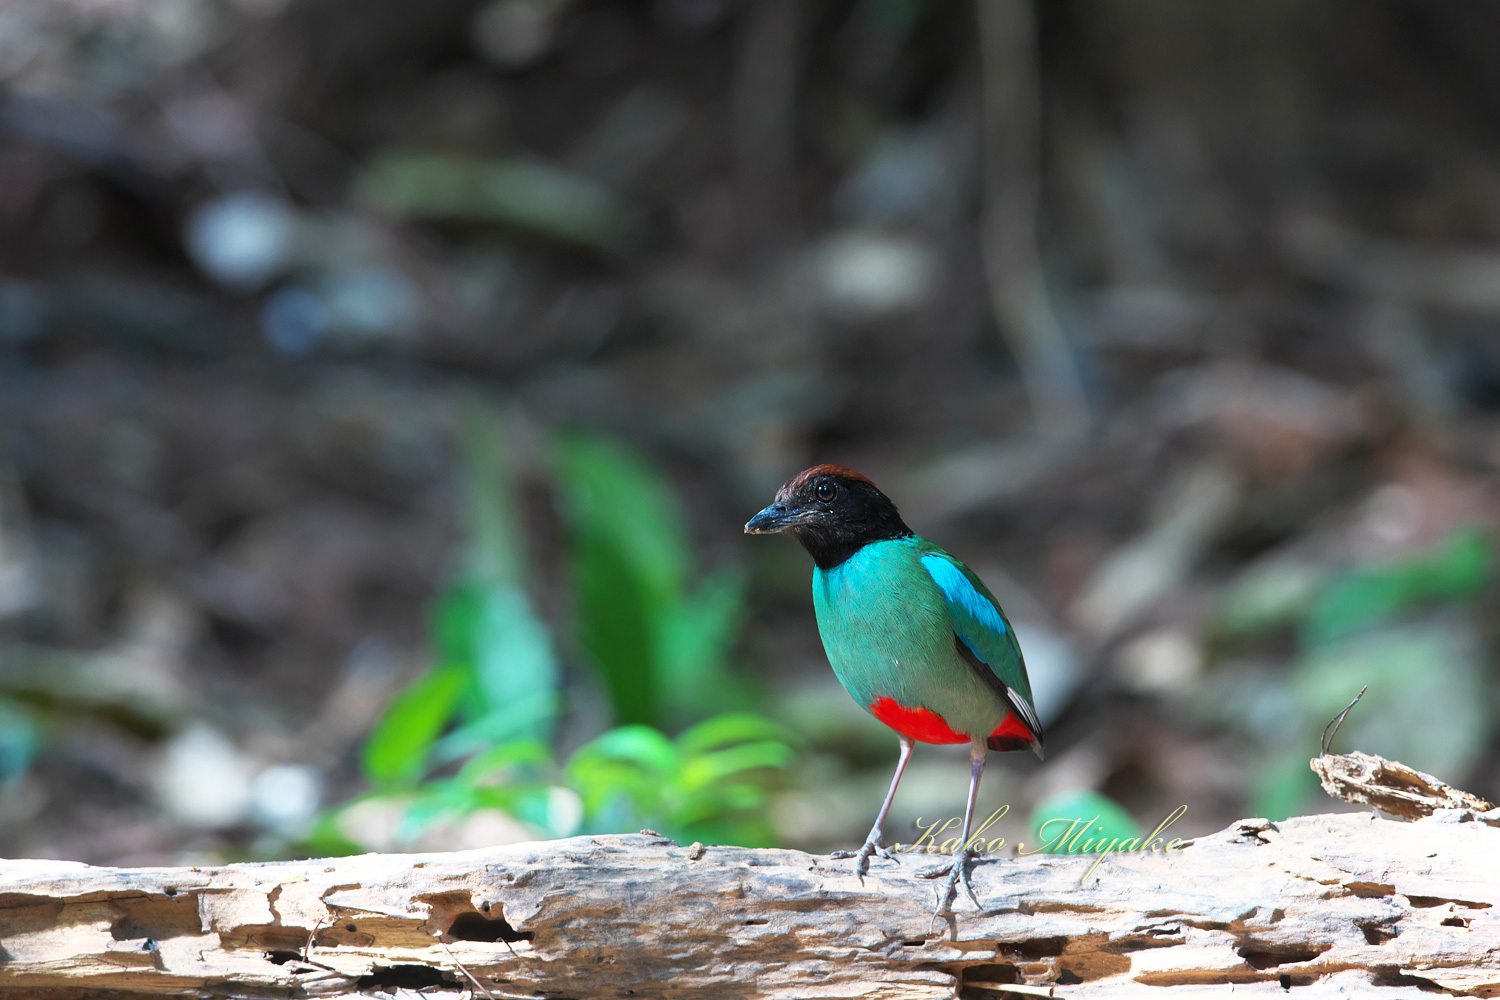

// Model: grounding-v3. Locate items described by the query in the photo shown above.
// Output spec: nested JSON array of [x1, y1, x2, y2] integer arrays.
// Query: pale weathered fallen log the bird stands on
[[0, 813, 1500, 1000]]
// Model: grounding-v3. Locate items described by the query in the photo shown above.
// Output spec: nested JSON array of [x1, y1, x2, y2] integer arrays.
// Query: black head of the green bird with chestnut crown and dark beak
[[746, 465, 912, 570]]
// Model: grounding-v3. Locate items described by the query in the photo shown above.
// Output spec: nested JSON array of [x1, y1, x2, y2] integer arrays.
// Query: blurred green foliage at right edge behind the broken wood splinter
[[1205, 528, 1496, 820]]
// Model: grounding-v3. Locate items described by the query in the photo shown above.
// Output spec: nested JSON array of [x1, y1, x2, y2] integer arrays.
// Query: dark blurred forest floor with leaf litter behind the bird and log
[[0, 0, 1500, 864]]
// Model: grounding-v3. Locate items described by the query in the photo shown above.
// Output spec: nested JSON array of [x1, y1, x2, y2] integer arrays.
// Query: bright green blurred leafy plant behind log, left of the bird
[[311, 412, 792, 853]]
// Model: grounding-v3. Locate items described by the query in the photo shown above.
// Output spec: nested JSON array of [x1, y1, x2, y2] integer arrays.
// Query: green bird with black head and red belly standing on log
[[746, 465, 1044, 921]]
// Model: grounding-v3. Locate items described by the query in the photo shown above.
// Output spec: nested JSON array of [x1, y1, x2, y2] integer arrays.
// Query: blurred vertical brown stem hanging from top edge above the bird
[[975, 0, 1089, 438]]
